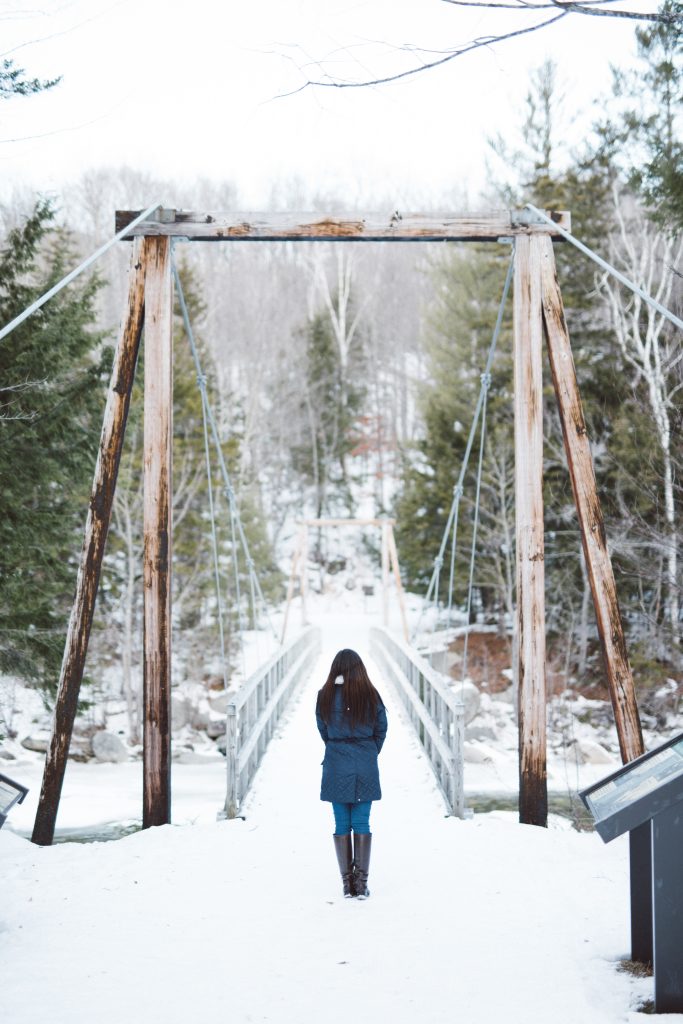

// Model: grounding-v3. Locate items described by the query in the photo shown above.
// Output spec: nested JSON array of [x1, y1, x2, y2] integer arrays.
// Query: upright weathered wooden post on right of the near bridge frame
[[514, 236, 548, 825]]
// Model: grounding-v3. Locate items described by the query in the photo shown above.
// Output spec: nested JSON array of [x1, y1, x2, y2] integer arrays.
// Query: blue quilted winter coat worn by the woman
[[315, 685, 387, 804]]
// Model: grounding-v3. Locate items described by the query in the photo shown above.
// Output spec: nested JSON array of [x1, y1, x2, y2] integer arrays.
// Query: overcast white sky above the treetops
[[0, 0, 656, 209]]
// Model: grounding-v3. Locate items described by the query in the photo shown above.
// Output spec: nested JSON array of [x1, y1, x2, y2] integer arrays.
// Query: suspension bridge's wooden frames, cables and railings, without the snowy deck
[[6, 205, 671, 845]]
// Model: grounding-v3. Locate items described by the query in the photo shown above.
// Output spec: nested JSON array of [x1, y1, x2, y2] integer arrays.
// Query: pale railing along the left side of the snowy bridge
[[224, 627, 321, 818]]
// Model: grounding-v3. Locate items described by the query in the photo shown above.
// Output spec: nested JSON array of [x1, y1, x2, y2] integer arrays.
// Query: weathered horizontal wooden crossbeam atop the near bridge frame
[[116, 210, 571, 242]]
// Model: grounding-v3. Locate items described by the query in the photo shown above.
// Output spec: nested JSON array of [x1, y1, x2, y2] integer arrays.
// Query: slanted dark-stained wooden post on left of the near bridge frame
[[32, 239, 146, 846]]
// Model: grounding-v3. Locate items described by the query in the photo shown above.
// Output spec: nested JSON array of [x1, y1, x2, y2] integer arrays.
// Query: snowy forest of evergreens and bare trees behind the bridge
[[0, 5, 683, 741]]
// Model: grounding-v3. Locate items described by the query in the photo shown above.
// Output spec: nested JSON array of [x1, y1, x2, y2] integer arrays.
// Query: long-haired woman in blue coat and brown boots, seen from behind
[[315, 649, 387, 899]]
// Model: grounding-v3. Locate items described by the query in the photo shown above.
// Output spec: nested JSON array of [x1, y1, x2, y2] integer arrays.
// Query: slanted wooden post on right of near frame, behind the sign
[[538, 238, 644, 763]]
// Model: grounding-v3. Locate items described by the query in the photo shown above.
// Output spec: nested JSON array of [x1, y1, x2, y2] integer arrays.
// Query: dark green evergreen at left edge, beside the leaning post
[[0, 202, 111, 693]]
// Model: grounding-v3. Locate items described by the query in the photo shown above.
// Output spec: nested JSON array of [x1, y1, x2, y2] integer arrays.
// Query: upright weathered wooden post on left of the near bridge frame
[[142, 238, 173, 828]]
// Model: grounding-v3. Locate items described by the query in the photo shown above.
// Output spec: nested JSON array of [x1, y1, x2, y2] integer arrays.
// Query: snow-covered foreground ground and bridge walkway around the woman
[[0, 616, 663, 1024]]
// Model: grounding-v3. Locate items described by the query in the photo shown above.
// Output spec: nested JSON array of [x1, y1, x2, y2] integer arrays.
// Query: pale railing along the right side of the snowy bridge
[[370, 629, 465, 818]]
